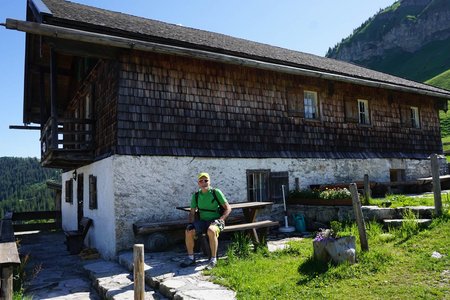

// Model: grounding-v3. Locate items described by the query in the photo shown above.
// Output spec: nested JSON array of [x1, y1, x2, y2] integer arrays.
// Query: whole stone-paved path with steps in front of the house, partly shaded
[[16, 232, 298, 300]]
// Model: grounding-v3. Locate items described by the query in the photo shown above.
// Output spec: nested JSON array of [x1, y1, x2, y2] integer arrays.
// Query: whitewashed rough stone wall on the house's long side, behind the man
[[109, 155, 430, 255]]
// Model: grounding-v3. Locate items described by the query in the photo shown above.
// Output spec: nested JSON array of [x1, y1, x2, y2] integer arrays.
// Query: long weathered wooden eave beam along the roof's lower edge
[[5, 19, 450, 100]]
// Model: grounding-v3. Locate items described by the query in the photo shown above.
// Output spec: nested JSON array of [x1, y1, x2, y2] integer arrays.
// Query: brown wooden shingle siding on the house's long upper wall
[[111, 52, 441, 158]]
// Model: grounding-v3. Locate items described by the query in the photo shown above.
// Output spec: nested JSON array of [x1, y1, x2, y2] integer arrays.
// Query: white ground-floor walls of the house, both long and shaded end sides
[[62, 155, 431, 258]]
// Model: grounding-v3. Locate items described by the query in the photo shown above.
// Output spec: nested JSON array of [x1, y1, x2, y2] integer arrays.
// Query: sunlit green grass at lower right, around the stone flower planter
[[211, 211, 450, 299]]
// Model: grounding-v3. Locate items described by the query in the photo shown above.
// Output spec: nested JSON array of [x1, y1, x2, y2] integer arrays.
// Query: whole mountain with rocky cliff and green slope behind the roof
[[326, 0, 450, 82]]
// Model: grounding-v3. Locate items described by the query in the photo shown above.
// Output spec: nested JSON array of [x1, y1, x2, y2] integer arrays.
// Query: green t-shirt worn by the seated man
[[191, 188, 228, 221]]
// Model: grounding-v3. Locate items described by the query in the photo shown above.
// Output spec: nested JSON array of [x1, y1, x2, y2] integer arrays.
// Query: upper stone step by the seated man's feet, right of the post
[[118, 251, 236, 300]]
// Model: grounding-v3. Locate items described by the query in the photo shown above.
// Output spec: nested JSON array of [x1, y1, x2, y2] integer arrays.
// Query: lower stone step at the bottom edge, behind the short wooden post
[[83, 259, 166, 300]]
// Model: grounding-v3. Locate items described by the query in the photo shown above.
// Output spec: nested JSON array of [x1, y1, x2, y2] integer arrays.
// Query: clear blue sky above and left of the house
[[0, 0, 395, 157]]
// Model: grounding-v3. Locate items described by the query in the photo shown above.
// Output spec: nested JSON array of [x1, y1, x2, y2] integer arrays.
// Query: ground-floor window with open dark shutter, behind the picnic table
[[247, 170, 289, 203]]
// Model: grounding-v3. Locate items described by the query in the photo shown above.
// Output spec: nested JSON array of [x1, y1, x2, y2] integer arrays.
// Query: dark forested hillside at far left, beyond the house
[[0, 157, 61, 217]]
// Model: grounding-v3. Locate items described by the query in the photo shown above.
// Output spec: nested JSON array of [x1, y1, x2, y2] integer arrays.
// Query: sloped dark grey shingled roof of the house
[[34, 0, 450, 98]]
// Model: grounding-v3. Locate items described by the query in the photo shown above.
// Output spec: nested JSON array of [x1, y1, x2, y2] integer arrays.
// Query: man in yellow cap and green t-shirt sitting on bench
[[180, 173, 231, 269]]
